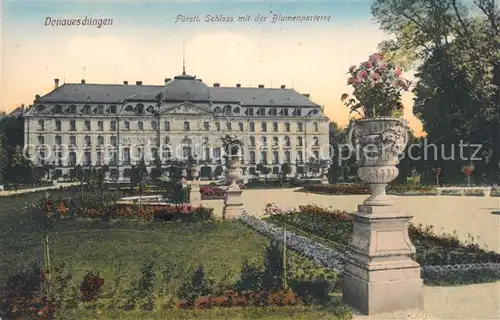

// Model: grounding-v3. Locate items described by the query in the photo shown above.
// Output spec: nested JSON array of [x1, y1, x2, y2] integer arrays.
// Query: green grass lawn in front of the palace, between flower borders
[[0, 190, 349, 320]]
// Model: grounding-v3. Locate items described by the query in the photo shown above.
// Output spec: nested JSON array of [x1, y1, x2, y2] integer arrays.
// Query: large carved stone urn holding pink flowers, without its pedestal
[[352, 117, 409, 206]]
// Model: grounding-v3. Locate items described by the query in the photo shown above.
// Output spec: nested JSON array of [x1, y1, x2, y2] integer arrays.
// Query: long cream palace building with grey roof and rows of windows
[[24, 71, 329, 177]]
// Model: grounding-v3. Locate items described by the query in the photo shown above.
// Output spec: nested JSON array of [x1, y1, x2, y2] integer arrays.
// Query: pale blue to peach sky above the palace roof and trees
[[0, 0, 422, 135]]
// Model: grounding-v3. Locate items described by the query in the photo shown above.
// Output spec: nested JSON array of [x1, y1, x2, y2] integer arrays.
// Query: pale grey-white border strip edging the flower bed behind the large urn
[[240, 214, 500, 279]]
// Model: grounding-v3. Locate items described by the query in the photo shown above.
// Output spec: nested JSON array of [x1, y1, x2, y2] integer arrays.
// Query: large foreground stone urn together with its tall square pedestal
[[343, 118, 423, 314]]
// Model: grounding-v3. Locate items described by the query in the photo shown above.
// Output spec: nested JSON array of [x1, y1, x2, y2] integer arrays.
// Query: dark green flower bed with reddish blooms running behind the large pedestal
[[266, 205, 500, 266]]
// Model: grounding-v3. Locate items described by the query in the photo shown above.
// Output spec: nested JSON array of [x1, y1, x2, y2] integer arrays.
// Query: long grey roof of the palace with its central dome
[[40, 79, 319, 107]]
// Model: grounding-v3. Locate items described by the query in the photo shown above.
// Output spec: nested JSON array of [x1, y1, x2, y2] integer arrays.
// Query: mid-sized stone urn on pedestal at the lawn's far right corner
[[222, 157, 245, 219]]
